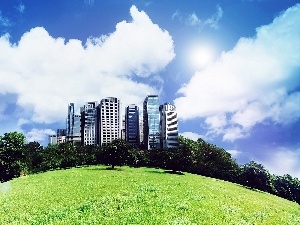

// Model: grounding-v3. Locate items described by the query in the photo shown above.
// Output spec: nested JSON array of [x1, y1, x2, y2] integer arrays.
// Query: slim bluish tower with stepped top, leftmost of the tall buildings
[[66, 103, 81, 144]]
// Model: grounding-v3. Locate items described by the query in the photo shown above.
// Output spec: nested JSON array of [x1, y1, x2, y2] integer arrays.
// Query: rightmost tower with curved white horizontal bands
[[159, 103, 179, 148]]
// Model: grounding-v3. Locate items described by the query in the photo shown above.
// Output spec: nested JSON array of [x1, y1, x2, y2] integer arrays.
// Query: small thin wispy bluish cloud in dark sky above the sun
[[172, 5, 223, 29]]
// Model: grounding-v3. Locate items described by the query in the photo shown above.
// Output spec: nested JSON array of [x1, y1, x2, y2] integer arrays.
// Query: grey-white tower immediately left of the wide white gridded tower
[[80, 102, 98, 145]]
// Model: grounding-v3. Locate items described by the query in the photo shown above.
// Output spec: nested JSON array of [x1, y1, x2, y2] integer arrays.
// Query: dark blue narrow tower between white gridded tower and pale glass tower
[[125, 104, 140, 146]]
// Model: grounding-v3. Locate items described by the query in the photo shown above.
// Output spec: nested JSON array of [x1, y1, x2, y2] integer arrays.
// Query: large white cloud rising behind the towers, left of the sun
[[0, 4, 175, 123]]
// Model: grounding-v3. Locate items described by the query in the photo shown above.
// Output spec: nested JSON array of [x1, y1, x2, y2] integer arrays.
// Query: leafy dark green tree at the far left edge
[[0, 132, 27, 181]]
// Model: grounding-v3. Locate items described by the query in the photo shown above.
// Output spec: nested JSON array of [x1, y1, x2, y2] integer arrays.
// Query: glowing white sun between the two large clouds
[[189, 45, 214, 69]]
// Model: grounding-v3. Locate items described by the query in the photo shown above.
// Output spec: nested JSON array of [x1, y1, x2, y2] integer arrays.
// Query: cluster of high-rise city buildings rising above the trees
[[49, 95, 178, 149]]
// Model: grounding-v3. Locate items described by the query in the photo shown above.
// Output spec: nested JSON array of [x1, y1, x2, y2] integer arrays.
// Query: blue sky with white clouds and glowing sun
[[0, 0, 300, 178]]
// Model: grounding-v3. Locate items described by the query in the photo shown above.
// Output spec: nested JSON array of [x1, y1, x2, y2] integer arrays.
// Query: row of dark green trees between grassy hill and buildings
[[0, 132, 300, 204]]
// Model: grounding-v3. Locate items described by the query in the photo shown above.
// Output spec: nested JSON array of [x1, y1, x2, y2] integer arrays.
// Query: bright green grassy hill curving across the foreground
[[0, 166, 300, 225]]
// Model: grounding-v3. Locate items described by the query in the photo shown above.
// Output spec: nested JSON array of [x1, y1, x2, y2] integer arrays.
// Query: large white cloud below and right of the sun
[[175, 4, 300, 141]]
